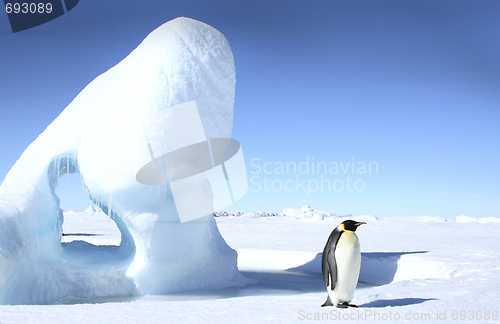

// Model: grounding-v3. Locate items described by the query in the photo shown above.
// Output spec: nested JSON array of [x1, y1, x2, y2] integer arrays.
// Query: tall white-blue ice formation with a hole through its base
[[0, 18, 238, 304]]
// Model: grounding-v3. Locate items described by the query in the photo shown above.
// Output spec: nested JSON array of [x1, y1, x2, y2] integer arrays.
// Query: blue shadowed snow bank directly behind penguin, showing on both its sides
[[288, 251, 429, 286]]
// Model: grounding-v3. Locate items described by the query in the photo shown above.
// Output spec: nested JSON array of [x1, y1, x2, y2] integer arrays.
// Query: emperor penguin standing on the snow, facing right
[[321, 220, 366, 308]]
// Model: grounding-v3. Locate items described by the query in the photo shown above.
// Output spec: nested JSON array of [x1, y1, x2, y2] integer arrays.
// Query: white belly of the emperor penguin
[[327, 231, 361, 305]]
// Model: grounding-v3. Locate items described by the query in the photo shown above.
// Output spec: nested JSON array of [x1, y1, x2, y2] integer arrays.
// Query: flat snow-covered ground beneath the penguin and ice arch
[[0, 211, 500, 324]]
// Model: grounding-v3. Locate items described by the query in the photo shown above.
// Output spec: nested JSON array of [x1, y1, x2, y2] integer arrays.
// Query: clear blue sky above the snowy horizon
[[0, 0, 500, 218]]
